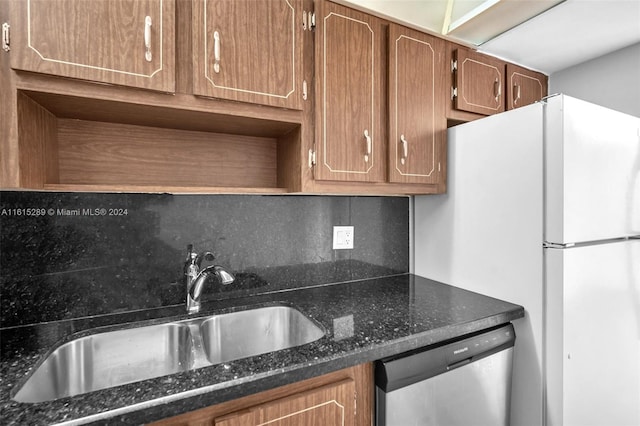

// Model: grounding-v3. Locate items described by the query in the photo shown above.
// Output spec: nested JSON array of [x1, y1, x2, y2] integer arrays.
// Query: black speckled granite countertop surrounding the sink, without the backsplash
[[0, 274, 524, 425]]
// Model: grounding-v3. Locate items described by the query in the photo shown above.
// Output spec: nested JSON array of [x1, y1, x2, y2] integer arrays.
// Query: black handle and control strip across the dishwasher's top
[[375, 323, 516, 392]]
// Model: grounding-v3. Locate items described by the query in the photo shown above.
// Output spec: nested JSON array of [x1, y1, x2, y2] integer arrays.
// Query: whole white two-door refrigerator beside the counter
[[413, 95, 640, 426]]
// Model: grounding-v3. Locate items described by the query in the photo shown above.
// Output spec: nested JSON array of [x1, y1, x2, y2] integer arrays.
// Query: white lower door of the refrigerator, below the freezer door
[[545, 240, 640, 426]]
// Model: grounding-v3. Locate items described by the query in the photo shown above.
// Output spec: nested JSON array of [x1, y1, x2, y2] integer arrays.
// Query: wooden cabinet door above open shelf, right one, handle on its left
[[193, 0, 303, 109]]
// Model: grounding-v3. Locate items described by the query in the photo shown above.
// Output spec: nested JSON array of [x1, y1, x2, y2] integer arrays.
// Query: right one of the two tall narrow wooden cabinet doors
[[389, 24, 447, 184]]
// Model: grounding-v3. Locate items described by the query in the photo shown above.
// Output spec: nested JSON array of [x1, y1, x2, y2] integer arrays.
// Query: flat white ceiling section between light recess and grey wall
[[479, 0, 640, 74]]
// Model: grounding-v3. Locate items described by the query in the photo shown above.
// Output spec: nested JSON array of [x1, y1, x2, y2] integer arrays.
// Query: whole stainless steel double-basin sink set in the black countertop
[[13, 306, 324, 402]]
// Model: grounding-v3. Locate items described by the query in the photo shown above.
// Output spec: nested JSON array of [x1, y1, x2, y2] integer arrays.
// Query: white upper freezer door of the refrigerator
[[545, 95, 640, 243]]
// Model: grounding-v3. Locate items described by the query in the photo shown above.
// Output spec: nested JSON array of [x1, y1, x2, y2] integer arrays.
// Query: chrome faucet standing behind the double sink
[[184, 244, 235, 314]]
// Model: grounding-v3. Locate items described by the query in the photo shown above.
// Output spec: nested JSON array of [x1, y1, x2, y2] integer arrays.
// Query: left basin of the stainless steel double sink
[[13, 323, 192, 402]]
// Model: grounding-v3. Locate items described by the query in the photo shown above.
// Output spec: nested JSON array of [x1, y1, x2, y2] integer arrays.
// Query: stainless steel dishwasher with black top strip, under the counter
[[375, 324, 515, 426]]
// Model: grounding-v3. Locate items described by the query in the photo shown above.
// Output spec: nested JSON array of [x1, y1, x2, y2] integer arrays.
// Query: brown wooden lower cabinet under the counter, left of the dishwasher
[[152, 363, 373, 426]]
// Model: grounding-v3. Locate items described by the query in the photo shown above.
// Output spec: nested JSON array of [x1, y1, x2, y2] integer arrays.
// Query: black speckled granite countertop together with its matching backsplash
[[0, 191, 524, 425]]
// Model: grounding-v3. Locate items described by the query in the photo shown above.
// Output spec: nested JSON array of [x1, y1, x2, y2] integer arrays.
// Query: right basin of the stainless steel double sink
[[201, 306, 324, 364]]
